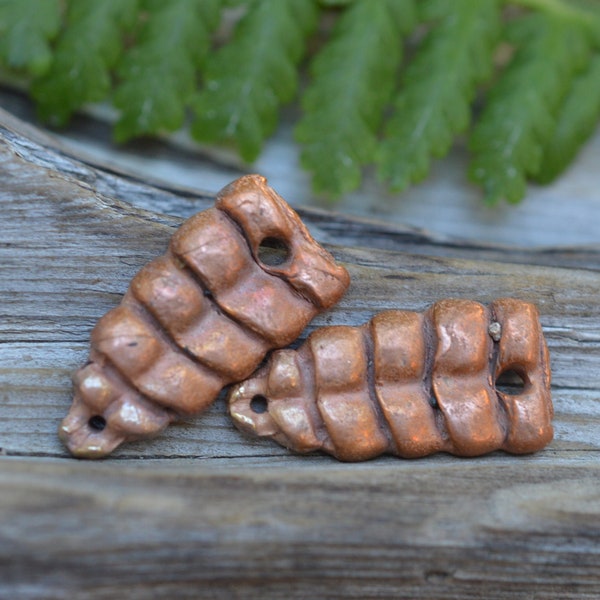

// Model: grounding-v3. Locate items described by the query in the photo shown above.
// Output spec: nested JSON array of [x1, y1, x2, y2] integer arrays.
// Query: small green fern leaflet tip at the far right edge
[[535, 55, 600, 183]]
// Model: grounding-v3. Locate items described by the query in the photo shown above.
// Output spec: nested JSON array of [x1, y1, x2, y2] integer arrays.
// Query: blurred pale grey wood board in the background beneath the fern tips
[[0, 86, 600, 251]]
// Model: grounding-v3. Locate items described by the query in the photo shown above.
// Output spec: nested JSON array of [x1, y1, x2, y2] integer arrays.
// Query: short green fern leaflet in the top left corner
[[0, 0, 61, 75]]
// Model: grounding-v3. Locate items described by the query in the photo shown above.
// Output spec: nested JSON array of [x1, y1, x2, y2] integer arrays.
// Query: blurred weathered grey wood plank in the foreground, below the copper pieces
[[0, 455, 600, 600]]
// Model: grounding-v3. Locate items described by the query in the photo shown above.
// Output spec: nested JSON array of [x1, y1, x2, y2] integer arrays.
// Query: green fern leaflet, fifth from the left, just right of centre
[[295, 0, 415, 195]]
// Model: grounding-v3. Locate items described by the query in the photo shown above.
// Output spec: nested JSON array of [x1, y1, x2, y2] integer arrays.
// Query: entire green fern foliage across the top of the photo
[[0, 0, 600, 203]]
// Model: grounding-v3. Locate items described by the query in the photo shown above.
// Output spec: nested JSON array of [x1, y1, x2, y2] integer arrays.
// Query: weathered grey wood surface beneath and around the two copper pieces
[[0, 113, 600, 600]]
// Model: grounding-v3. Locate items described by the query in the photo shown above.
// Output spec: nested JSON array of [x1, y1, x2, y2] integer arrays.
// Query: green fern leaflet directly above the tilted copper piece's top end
[[192, 0, 318, 162]]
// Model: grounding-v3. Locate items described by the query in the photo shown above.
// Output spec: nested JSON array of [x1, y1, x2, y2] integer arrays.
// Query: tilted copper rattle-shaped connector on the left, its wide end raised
[[59, 175, 349, 458]]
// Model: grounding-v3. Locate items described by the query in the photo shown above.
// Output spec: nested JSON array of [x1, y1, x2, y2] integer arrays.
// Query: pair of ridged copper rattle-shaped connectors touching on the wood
[[59, 175, 552, 461]]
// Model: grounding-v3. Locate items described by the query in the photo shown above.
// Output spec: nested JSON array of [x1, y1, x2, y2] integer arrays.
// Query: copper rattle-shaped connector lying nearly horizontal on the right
[[229, 298, 553, 461]]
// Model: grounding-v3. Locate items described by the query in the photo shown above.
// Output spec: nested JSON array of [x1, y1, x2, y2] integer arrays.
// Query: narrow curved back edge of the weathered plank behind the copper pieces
[[0, 109, 600, 270]]
